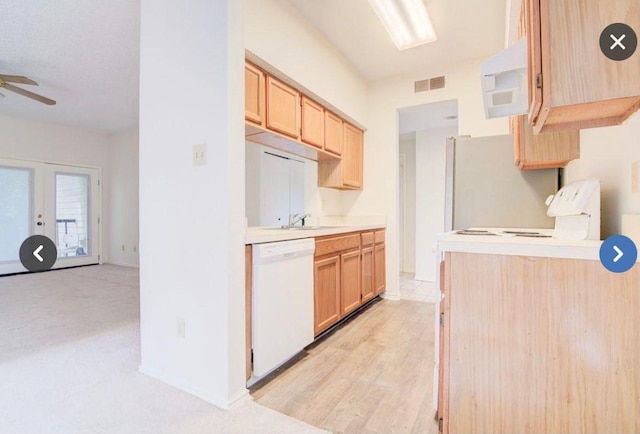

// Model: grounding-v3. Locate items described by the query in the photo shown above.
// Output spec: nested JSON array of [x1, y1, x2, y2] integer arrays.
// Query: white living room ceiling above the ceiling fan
[[0, 0, 140, 131]]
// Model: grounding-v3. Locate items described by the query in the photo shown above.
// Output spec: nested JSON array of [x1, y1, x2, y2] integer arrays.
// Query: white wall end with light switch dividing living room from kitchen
[[139, 0, 247, 407]]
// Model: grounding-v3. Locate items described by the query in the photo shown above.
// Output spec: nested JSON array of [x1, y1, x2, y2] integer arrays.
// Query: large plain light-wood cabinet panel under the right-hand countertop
[[438, 252, 640, 433]]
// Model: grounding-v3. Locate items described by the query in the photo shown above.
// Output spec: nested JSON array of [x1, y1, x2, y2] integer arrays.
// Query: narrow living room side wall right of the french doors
[[105, 127, 140, 267]]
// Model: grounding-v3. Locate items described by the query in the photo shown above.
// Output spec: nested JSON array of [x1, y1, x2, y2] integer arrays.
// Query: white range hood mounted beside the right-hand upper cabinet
[[480, 38, 529, 119]]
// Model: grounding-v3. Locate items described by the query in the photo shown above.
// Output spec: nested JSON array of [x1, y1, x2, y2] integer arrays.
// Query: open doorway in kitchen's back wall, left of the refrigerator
[[398, 100, 458, 288]]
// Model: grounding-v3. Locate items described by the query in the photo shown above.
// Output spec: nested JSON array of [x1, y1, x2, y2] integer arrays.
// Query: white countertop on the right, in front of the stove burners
[[437, 228, 602, 261]]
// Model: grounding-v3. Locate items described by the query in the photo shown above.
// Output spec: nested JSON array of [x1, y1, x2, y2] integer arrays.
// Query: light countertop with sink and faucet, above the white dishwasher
[[244, 224, 386, 244]]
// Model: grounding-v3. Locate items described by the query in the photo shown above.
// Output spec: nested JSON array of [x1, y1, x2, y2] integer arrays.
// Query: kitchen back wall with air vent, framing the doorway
[[342, 59, 508, 297]]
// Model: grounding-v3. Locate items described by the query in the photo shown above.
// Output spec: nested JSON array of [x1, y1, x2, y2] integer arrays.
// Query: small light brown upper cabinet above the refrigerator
[[511, 115, 580, 170]]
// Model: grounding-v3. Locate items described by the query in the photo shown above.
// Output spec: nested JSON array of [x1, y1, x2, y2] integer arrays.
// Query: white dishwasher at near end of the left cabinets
[[248, 238, 315, 385]]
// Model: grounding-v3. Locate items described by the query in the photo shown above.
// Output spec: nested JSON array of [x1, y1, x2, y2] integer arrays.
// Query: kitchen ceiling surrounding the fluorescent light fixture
[[289, 0, 508, 81]]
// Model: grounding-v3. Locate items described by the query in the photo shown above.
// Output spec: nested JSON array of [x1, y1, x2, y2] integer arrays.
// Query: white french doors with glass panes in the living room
[[0, 159, 101, 275]]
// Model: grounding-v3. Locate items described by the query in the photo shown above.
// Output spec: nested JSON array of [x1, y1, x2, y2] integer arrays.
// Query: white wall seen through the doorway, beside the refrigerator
[[416, 128, 458, 282]]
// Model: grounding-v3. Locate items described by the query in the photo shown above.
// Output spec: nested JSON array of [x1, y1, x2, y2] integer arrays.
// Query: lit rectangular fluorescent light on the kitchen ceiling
[[369, 0, 437, 50]]
